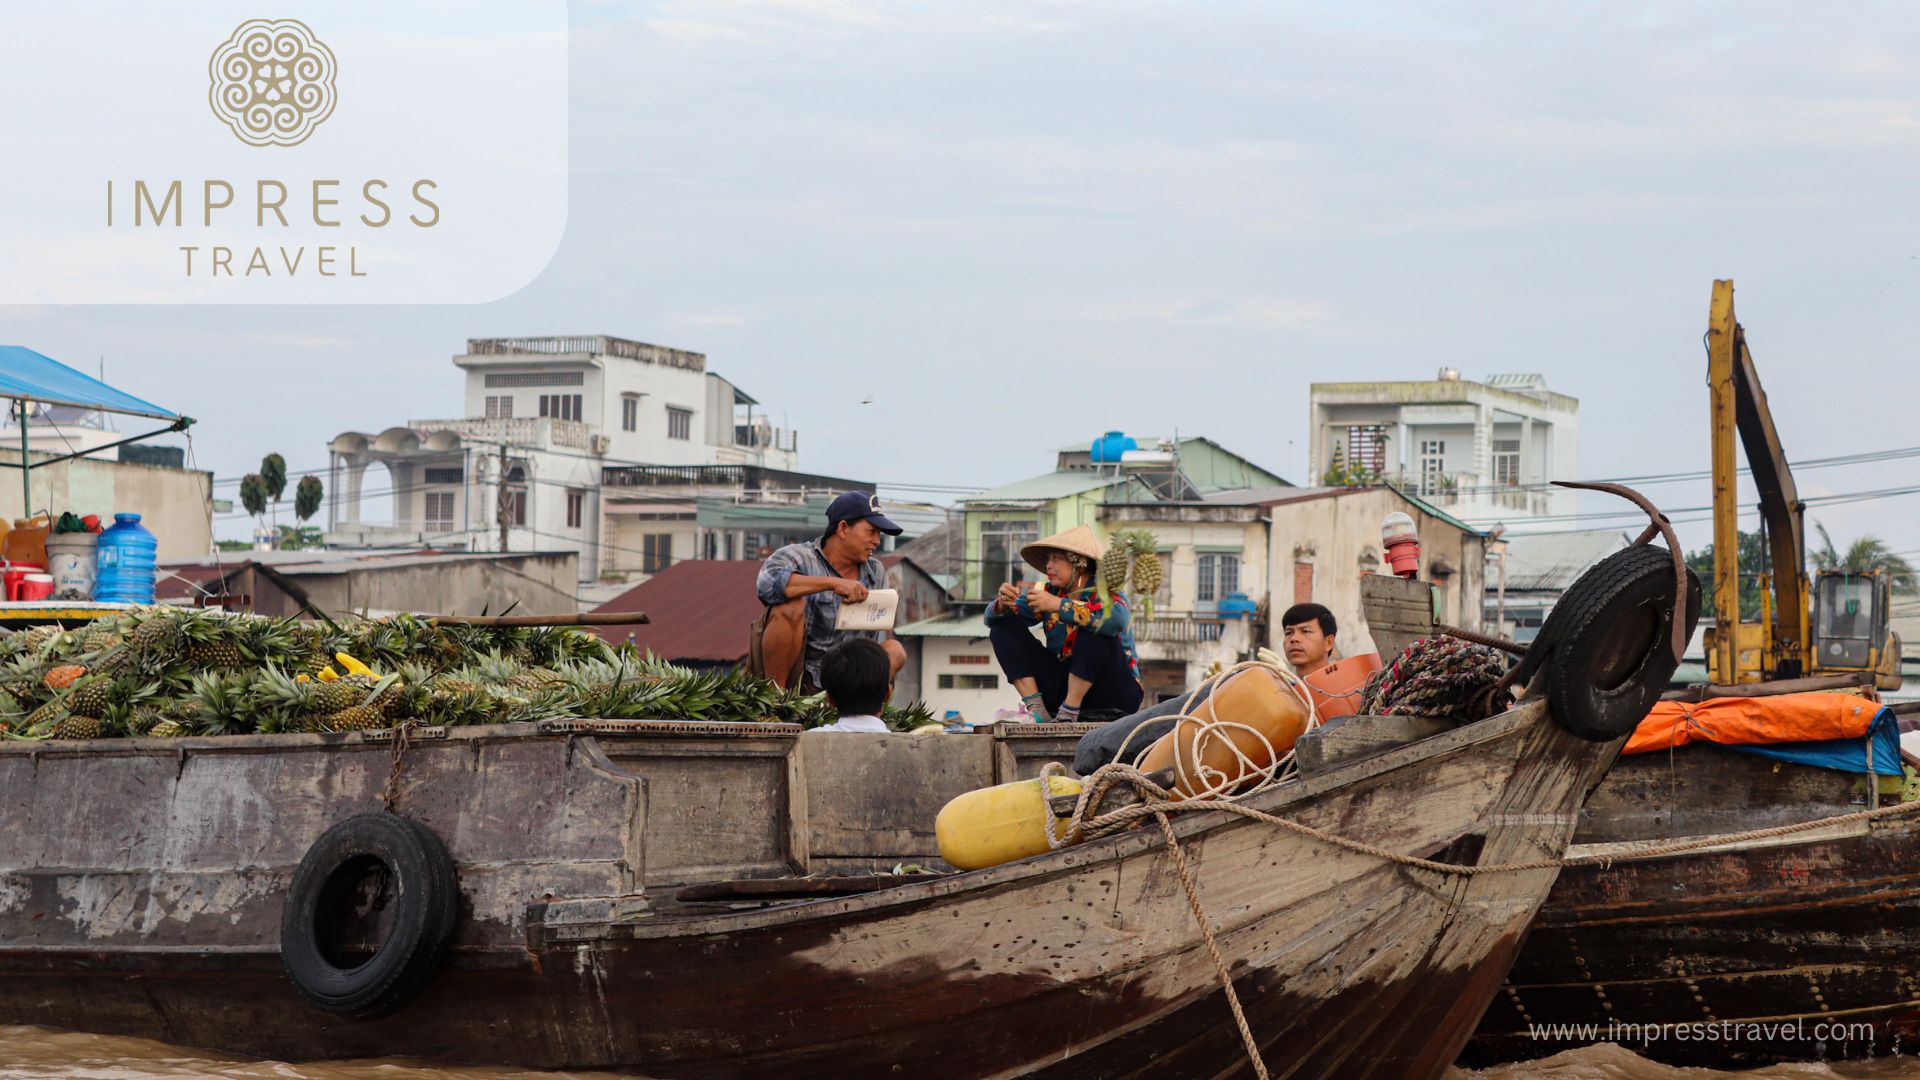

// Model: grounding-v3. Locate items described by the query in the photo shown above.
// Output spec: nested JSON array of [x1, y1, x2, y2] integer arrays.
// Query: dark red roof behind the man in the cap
[[595, 559, 762, 663]]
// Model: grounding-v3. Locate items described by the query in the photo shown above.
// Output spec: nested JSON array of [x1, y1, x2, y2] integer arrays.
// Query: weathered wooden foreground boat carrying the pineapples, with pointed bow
[[0, 701, 1619, 1078]]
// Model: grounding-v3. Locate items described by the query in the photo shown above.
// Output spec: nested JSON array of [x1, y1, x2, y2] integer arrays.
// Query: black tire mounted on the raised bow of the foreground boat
[[1521, 544, 1701, 742]]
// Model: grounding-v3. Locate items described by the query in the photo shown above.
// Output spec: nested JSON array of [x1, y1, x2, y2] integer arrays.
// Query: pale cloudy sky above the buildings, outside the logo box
[[0, 0, 1920, 550]]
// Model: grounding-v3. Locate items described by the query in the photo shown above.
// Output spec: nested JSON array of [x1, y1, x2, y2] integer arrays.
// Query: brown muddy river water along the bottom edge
[[0, 1026, 1920, 1080]]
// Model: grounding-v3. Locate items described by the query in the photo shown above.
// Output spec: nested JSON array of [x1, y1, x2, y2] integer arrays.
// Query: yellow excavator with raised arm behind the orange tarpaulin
[[1707, 281, 1901, 690]]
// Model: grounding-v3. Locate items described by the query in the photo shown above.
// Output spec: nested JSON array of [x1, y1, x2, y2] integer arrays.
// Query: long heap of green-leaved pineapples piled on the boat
[[0, 605, 933, 740]]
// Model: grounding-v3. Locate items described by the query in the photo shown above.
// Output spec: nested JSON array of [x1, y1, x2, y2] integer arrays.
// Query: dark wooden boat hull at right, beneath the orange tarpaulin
[[1463, 688, 1920, 1068]]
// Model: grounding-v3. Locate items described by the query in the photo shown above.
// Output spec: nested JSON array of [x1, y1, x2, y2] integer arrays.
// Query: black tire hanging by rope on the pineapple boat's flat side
[[280, 813, 459, 1020]]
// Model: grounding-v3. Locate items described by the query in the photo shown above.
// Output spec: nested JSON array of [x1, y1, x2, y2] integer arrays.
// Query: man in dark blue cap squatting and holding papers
[[756, 492, 906, 692]]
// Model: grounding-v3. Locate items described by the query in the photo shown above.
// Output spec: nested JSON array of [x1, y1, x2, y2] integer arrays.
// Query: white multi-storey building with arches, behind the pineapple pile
[[326, 336, 799, 580]]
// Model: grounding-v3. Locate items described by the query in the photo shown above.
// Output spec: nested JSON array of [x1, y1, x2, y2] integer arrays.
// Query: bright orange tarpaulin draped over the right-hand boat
[[1620, 692, 1882, 753]]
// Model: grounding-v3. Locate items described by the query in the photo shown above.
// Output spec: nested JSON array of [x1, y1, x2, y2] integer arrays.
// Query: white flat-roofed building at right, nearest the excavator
[[1308, 369, 1580, 525]]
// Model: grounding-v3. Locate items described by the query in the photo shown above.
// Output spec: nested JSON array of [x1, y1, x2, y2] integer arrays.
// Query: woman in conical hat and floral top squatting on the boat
[[987, 525, 1144, 723]]
